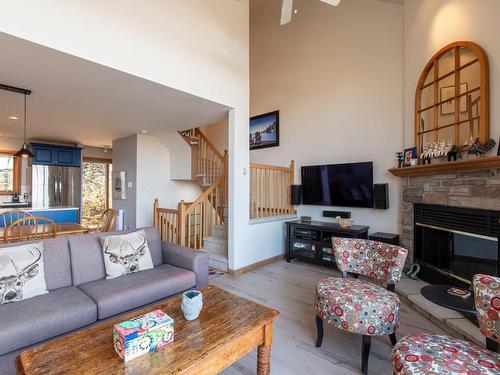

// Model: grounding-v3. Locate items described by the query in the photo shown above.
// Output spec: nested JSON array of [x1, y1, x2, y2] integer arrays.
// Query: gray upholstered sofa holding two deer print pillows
[[0, 228, 208, 375]]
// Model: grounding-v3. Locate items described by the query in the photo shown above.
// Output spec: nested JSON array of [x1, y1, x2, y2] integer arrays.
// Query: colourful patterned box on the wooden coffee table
[[113, 310, 174, 362]]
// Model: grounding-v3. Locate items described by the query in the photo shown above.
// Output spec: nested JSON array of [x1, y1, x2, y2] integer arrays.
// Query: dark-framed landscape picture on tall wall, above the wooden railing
[[250, 111, 280, 150]]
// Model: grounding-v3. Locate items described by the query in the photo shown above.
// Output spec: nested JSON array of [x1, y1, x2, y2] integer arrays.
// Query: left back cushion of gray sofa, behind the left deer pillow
[[0, 237, 72, 290]]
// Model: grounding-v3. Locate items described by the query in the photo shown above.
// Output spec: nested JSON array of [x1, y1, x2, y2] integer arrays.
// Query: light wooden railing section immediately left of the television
[[250, 160, 296, 219]]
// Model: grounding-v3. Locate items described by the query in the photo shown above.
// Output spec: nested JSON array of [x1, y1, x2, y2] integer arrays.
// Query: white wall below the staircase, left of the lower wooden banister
[[137, 135, 202, 227]]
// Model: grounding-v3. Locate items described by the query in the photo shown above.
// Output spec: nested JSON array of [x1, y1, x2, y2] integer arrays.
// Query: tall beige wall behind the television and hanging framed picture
[[250, 0, 403, 264]]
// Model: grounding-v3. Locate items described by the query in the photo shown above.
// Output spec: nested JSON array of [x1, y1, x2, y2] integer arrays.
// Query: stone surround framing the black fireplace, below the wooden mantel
[[401, 169, 500, 278]]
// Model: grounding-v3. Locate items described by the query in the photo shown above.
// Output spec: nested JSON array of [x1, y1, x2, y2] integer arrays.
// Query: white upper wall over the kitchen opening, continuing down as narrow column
[[0, 0, 253, 268]]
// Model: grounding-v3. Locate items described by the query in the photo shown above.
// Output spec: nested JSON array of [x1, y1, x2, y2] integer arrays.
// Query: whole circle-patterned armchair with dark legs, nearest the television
[[316, 237, 408, 374]]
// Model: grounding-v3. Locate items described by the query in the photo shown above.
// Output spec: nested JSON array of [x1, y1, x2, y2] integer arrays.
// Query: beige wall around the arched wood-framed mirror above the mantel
[[404, 0, 500, 150]]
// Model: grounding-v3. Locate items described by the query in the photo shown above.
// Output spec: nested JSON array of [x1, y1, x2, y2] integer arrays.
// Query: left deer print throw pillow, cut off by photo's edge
[[0, 242, 48, 304]]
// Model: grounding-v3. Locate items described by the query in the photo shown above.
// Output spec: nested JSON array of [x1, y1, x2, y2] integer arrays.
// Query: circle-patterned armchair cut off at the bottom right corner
[[392, 275, 500, 375]]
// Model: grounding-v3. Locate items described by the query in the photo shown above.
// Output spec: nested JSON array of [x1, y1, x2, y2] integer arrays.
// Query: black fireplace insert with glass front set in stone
[[413, 203, 500, 287]]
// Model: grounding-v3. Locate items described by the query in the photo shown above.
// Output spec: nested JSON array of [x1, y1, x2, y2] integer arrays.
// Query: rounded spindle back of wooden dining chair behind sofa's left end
[[3, 216, 56, 243]]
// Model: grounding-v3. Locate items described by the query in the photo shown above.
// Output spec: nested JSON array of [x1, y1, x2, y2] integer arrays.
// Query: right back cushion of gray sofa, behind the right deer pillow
[[68, 228, 163, 285]]
